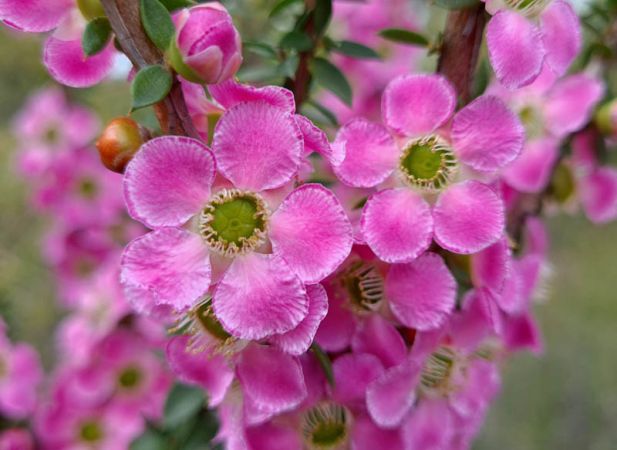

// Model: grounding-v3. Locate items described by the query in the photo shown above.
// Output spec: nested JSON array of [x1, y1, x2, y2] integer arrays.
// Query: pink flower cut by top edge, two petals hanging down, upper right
[[484, 0, 582, 89]]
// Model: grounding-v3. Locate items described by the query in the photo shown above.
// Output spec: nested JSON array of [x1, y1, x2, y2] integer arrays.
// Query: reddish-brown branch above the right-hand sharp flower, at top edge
[[437, 3, 486, 103]]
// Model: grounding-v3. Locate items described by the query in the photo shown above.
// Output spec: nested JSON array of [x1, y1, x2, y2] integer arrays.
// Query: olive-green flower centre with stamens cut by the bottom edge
[[302, 403, 348, 450]]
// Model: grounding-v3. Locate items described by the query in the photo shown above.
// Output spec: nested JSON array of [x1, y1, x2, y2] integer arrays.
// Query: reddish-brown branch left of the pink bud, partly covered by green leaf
[[101, 0, 199, 138]]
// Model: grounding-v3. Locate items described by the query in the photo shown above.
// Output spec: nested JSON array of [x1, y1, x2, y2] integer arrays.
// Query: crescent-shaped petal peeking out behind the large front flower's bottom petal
[[271, 284, 328, 355]]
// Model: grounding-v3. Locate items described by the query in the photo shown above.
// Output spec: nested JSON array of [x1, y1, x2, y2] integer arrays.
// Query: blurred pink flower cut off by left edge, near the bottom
[[0, 321, 43, 419]]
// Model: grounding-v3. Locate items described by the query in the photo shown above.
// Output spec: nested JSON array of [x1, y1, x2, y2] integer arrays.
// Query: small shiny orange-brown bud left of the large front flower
[[96, 117, 147, 173]]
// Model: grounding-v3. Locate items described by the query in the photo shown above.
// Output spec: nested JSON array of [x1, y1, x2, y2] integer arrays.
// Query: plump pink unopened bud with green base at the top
[[168, 3, 242, 84]]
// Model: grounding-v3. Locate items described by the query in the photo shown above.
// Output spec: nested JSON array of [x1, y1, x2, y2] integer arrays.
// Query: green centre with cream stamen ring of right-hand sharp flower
[[399, 136, 456, 190]]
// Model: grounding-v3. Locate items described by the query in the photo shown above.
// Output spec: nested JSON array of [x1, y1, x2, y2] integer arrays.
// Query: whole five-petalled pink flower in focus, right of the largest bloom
[[332, 75, 523, 263]]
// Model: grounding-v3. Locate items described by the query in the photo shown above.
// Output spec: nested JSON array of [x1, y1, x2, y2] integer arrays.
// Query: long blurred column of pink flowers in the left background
[[0, 88, 172, 450]]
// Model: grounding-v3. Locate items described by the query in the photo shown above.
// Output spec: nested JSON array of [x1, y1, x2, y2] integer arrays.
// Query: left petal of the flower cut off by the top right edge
[[486, 10, 545, 89]]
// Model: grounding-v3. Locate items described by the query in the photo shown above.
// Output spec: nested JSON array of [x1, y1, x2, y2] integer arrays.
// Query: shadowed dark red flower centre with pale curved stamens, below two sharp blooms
[[340, 261, 384, 311]]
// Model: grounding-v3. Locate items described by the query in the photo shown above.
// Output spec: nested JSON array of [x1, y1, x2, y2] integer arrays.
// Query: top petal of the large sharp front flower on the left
[[212, 101, 304, 191]]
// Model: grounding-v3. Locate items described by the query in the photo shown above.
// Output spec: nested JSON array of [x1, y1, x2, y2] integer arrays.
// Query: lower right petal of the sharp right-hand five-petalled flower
[[433, 180, 505, 254]]
